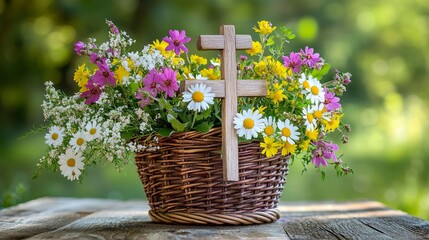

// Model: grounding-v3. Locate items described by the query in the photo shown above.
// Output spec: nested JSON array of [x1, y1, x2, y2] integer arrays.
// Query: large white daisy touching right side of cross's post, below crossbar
[[234, 109, 264, 140]]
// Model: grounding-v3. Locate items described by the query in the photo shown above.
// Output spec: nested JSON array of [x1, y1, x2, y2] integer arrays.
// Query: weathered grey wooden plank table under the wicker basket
[[0, 198, 429, 240]]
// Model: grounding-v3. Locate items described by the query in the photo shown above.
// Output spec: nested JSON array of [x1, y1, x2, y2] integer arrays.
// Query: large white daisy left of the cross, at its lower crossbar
[[183, 83, 214, 112]]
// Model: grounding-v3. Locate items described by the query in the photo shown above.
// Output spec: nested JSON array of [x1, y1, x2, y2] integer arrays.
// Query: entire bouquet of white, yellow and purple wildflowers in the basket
[[38, 21, 351, 180]]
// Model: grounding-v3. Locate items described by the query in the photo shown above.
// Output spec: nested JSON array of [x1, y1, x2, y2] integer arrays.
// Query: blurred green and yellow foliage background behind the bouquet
[[0, 0, 429, 219]]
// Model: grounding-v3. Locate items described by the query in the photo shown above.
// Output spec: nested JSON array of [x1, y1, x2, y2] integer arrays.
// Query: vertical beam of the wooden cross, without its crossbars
[[220, 25, 239, 181]]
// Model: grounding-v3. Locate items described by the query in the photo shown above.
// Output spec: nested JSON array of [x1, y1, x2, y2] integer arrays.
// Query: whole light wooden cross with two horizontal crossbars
[[181, 25, 267, 181]]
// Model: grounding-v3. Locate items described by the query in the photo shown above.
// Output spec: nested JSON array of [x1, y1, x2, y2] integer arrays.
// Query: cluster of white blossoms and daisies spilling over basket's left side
[[39, 82, 153, 180]]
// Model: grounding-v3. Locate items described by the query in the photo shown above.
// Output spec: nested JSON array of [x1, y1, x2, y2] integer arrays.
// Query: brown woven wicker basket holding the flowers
[[135, 128, 289, 225]]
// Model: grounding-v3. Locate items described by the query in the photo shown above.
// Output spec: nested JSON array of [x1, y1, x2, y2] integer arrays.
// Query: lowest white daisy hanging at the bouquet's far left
[[58, 148, 84, 181]]
